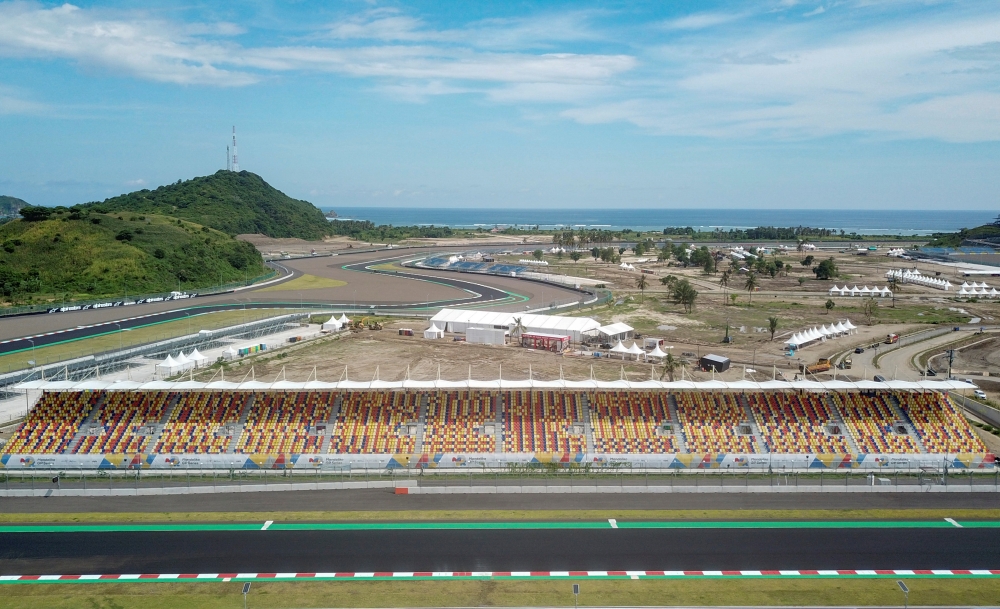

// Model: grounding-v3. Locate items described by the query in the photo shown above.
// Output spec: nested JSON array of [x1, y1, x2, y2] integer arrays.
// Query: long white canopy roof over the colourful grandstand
[[15, 379, 975, 392]]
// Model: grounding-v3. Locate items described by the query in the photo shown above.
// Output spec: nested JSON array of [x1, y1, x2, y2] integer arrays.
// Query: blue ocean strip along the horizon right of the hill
[[322, 207, 996, 235]]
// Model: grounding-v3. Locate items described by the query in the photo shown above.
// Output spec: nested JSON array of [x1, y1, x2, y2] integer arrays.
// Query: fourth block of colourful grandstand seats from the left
[[236, 391, 336, 454]]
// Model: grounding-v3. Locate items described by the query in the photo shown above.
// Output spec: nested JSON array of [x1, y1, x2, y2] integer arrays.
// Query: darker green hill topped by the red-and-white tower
[[84, 170, 330, 240]]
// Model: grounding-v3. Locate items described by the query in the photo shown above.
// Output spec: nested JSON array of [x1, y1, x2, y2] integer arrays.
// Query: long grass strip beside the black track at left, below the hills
[[0, 309, 293, 372]]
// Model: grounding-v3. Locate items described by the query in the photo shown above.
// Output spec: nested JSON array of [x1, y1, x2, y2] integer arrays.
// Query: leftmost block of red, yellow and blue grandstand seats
[[3, 391, 103, 454]]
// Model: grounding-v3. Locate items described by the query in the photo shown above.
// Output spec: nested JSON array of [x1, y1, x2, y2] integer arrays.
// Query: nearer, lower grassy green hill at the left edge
[[0, 206, 266, 302]]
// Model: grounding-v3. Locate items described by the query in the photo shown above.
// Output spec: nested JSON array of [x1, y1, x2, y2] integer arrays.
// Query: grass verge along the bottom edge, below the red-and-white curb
[[0, 578, 1000, 609]]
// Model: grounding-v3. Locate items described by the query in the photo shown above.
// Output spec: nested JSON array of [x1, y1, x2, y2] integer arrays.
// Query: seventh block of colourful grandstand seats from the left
[[503, 391, 587, 453]]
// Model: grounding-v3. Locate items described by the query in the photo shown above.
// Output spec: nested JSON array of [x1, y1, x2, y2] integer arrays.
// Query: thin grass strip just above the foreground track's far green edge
[[0, 509, 1000, 524]]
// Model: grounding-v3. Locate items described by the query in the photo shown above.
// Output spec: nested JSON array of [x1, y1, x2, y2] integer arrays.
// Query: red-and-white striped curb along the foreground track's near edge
[[0, 569, 1000, 584]]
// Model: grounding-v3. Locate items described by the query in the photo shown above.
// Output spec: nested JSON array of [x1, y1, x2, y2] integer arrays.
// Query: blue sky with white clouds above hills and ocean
[[0, 0, 1000, 210]]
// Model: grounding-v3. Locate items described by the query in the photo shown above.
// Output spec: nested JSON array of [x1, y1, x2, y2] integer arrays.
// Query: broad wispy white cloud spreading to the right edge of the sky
[[563, 8, 1000, 142]]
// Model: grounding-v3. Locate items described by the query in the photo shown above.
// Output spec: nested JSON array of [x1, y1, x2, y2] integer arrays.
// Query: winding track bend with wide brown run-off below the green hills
[[0, 248, 580, 355]]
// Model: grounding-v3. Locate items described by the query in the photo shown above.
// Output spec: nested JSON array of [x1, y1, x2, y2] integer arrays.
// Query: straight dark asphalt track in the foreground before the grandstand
[[0, 528, 1000, 574]]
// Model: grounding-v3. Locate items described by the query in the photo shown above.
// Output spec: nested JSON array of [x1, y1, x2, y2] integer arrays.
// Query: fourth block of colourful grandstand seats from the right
[[674, 392, 757, 454]]
